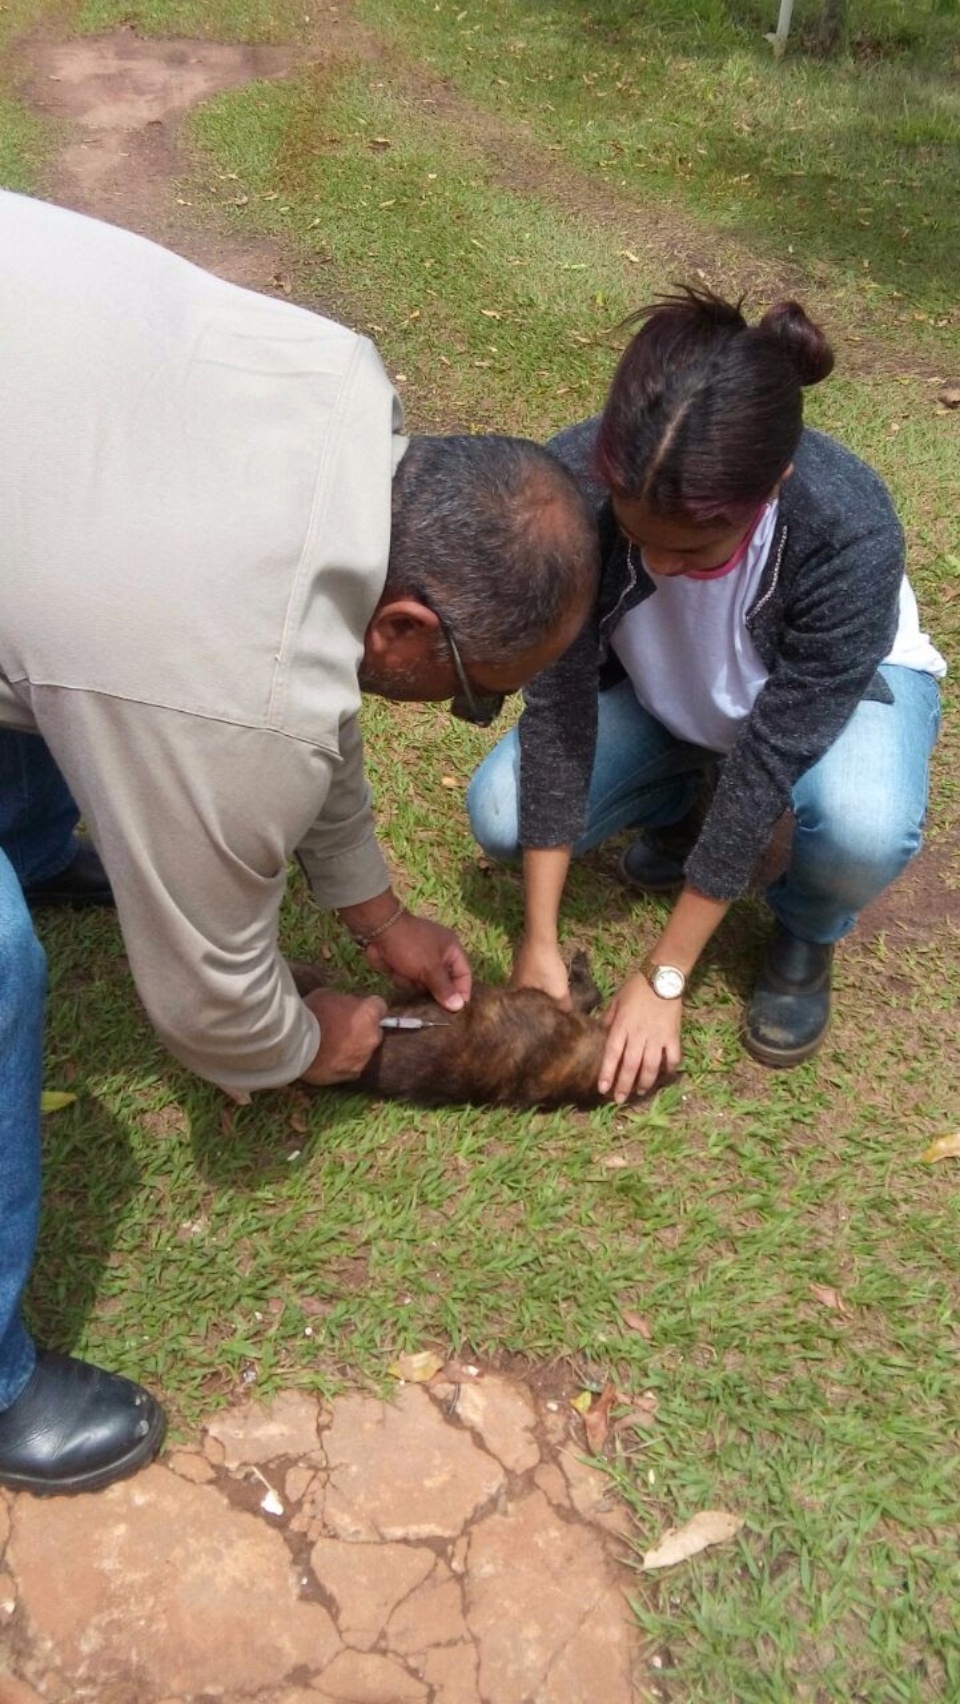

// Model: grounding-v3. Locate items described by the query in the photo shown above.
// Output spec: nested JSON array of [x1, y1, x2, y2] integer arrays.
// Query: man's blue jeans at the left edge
[[0, 728, 77, 1409]]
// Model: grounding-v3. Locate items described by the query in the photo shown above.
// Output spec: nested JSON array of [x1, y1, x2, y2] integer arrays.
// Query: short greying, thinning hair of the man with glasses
[[387, 436, 599, 661]]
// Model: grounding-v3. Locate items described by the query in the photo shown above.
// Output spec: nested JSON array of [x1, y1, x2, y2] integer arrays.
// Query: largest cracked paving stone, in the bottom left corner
[[9, 1467, 341, 1701]]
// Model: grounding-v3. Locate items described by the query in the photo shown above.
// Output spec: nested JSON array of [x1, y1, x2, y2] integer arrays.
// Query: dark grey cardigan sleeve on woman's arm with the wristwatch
[[685, 511, 904, 900]]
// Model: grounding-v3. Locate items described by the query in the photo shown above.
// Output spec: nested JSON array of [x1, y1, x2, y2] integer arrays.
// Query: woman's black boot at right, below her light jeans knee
[[740, 924, 834, 1067]]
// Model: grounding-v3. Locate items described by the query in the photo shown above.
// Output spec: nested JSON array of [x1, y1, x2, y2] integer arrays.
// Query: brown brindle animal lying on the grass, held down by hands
[[292, 953, 624, 1106]]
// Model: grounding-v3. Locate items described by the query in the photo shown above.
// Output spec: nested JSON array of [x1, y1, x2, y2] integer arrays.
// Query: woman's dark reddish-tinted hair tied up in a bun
[[595, 286, 834, 525]]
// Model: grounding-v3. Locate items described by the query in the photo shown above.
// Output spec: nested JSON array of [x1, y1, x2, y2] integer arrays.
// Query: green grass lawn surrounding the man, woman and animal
[[0, 0, 960, 1704]]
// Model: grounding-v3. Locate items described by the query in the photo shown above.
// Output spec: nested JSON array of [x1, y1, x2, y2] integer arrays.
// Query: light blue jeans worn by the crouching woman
[[467, 663, 940, 944]]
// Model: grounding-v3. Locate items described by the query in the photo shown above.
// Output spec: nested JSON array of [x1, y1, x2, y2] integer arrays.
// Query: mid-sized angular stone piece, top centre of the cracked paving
[[322, 1385, 506, 1542]]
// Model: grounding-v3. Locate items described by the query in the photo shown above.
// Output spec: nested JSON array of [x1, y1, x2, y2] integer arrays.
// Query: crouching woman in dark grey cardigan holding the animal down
[[467, 290, 945, 1101]]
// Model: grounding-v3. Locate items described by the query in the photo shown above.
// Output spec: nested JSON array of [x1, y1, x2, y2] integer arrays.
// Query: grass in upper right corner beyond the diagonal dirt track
[[352, 0, 960, 332]]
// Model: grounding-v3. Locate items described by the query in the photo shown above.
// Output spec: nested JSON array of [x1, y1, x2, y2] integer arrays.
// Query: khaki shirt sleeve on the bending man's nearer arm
[[34, 688, 383, 1099]]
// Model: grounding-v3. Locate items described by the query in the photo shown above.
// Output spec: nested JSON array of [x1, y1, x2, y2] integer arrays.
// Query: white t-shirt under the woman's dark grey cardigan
[[610, 501, 946, 751]]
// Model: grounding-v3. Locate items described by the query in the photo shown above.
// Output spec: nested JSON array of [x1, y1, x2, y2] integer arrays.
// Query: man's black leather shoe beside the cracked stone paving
[[0, 1350, 167, 1496]]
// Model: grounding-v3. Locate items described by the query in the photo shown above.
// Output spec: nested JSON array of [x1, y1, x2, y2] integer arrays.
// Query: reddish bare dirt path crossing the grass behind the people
[[19, 9, 948, 378]]
